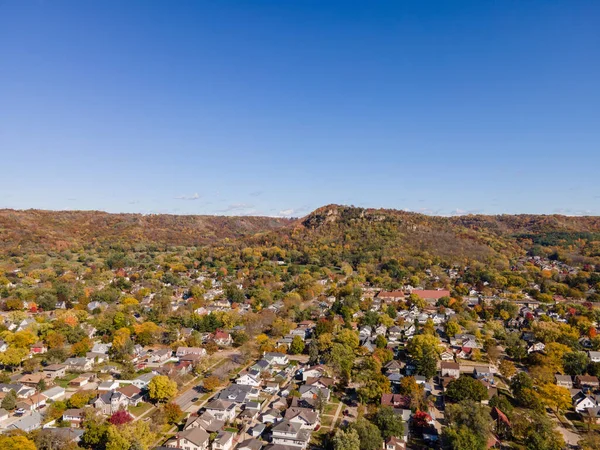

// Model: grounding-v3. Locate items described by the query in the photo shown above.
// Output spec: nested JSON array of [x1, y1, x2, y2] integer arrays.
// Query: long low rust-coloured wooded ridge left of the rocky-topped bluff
[[0, 209, 289, 251]]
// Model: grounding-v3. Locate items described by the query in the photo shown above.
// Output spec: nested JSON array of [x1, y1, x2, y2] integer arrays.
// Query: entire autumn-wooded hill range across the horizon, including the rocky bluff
[[0, 205, 600, 264]]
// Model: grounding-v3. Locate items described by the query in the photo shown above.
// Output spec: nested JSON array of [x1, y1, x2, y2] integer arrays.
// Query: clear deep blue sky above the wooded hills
[[0, 0, 600, 216]]
